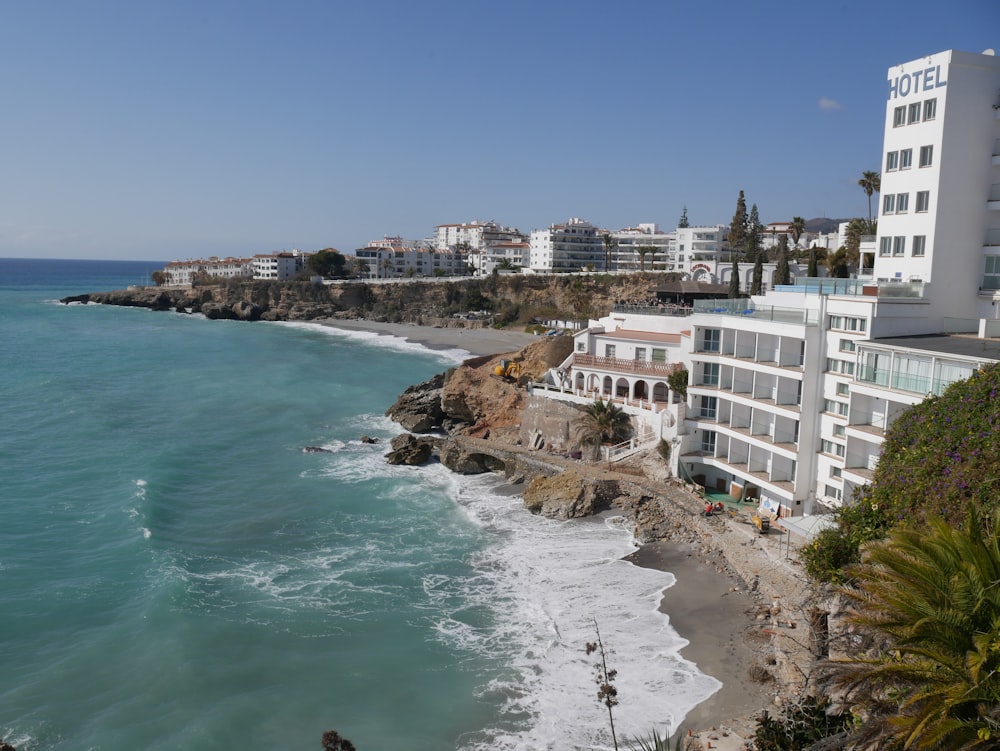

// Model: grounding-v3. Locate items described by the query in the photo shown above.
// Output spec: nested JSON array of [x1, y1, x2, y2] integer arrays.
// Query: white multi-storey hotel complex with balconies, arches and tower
[[535, 51, 1000, 516]]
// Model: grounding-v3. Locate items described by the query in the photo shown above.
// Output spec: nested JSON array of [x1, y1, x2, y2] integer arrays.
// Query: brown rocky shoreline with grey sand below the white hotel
[[387, 338, 816, 749]]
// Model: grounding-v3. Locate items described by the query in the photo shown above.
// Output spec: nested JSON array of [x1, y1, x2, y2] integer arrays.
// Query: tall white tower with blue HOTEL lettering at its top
[[874, 50, 1000, 327]]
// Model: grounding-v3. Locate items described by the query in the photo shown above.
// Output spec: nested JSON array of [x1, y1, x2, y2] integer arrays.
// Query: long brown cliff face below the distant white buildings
[[63, 273, 674, 323]]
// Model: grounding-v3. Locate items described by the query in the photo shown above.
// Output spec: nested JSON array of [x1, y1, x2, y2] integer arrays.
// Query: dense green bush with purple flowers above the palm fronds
[[801, 364, 1000, 581]]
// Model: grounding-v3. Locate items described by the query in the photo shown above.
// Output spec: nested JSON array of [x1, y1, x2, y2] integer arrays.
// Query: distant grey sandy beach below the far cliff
[[316, 318, 539, 355]]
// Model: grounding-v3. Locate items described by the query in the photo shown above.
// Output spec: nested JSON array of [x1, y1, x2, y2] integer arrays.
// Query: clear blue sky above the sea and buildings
[[0, 0, 1000, 260]]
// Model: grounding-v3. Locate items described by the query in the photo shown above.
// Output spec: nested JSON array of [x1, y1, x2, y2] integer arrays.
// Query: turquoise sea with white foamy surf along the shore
[[0, 259, 719, 751]]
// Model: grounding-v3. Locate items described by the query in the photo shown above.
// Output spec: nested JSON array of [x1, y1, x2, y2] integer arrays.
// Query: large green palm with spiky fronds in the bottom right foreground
[[827, 508, 1000, 751]]
